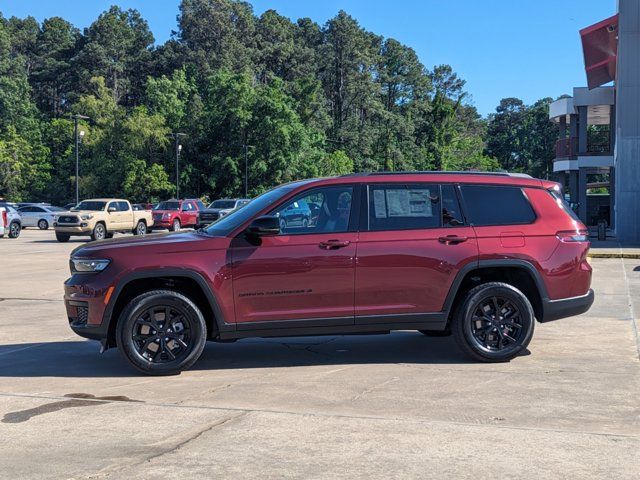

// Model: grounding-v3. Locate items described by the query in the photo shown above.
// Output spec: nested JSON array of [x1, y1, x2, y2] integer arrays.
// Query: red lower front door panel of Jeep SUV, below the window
[[232, 233, 357, 323]]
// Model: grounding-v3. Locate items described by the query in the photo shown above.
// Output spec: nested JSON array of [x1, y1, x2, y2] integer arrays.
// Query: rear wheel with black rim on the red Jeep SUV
[[451, 282, 535, 362]]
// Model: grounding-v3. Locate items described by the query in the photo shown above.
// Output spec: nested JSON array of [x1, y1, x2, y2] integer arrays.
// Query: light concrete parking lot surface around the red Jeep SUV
[[0, 229, 640, 479]]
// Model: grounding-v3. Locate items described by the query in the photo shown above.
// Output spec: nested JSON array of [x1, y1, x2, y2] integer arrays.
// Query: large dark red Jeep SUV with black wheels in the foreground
[[64, 172, 593, 375]]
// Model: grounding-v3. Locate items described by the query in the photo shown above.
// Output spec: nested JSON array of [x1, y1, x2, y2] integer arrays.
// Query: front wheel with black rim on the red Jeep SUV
[[116, 290, 207, 375]]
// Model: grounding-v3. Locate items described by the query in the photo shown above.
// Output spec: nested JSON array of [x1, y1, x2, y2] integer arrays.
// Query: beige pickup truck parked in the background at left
[[54, 198, 153, 242]]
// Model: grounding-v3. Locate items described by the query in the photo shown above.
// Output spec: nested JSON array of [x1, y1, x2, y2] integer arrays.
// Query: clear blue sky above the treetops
[[0, 0, 616, 115]]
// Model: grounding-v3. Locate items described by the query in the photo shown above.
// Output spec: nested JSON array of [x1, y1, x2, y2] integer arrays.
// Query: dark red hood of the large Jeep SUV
[[71, 232, 228, 257]]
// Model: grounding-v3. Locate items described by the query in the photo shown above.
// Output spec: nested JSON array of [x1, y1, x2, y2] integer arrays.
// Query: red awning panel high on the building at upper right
[[580, 14, 618, 89]]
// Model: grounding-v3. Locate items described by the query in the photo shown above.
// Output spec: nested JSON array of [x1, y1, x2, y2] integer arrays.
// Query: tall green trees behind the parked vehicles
[[0, 0, 556, 204]]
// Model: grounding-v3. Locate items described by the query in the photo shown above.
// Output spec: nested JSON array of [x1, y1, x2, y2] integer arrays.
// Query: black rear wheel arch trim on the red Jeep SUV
[[444, 259, 549, 321]]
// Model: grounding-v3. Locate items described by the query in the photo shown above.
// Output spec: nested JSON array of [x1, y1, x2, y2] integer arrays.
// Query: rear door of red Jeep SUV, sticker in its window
[[355, 183, 478, 323]]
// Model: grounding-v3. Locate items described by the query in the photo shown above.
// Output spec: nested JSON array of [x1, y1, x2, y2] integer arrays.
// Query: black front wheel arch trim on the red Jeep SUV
[[102, 268, 228, 346]]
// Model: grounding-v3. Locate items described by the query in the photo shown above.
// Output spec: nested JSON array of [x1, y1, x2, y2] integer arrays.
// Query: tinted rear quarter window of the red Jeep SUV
[[460, 185, 536, 227]]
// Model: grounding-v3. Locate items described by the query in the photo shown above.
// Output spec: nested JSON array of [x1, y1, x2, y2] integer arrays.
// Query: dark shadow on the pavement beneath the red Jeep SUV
[[0, 331, 480, 377]]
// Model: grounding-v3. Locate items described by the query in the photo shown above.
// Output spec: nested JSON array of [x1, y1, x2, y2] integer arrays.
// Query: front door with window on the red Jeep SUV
[[231, 185, 358, 325]]
